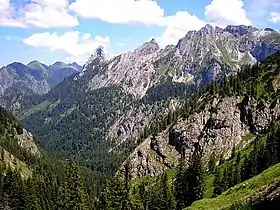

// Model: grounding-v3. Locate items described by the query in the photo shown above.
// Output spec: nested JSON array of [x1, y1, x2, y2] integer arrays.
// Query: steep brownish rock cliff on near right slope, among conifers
[[124, 96, 280, 178]]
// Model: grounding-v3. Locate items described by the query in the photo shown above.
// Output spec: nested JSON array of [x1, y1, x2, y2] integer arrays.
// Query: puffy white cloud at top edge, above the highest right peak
[[205, 0, 251, 26]]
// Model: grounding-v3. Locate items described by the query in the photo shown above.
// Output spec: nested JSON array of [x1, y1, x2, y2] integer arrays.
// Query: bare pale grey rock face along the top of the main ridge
[[84, 25, 280, 97]]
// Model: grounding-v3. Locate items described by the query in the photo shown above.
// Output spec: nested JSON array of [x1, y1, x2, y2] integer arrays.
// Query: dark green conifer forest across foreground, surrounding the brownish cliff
[[0, 53, 280, 210]]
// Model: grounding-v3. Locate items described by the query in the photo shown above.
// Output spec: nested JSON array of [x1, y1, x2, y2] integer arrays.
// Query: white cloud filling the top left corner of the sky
[[0, 0, 79, 28]]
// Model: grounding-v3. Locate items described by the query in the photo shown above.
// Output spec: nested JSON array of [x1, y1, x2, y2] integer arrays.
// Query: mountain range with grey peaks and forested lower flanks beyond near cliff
[[11, 25, 280, 173]]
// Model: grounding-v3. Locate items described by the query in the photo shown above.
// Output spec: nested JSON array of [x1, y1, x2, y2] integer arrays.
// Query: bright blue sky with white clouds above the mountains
[[0, 0, 280, 66]]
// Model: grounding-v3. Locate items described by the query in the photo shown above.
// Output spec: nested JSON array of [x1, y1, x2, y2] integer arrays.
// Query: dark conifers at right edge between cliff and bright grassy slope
[[213, 122, 280, 197]]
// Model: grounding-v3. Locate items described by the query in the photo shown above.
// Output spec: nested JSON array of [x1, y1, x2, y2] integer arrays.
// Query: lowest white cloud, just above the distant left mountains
[[23, 31, 110, 62]]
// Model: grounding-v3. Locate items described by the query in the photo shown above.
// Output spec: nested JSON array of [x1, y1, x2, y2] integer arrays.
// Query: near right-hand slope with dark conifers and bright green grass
[[94, 53, 280, 209]]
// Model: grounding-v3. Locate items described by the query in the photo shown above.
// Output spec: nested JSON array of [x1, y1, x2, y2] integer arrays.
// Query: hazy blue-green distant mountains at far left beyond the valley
[[0, 61, 78, 109]]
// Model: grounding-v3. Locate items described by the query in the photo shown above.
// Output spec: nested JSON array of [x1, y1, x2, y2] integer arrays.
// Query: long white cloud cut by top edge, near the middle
[[70, 0, 164, 25]]
